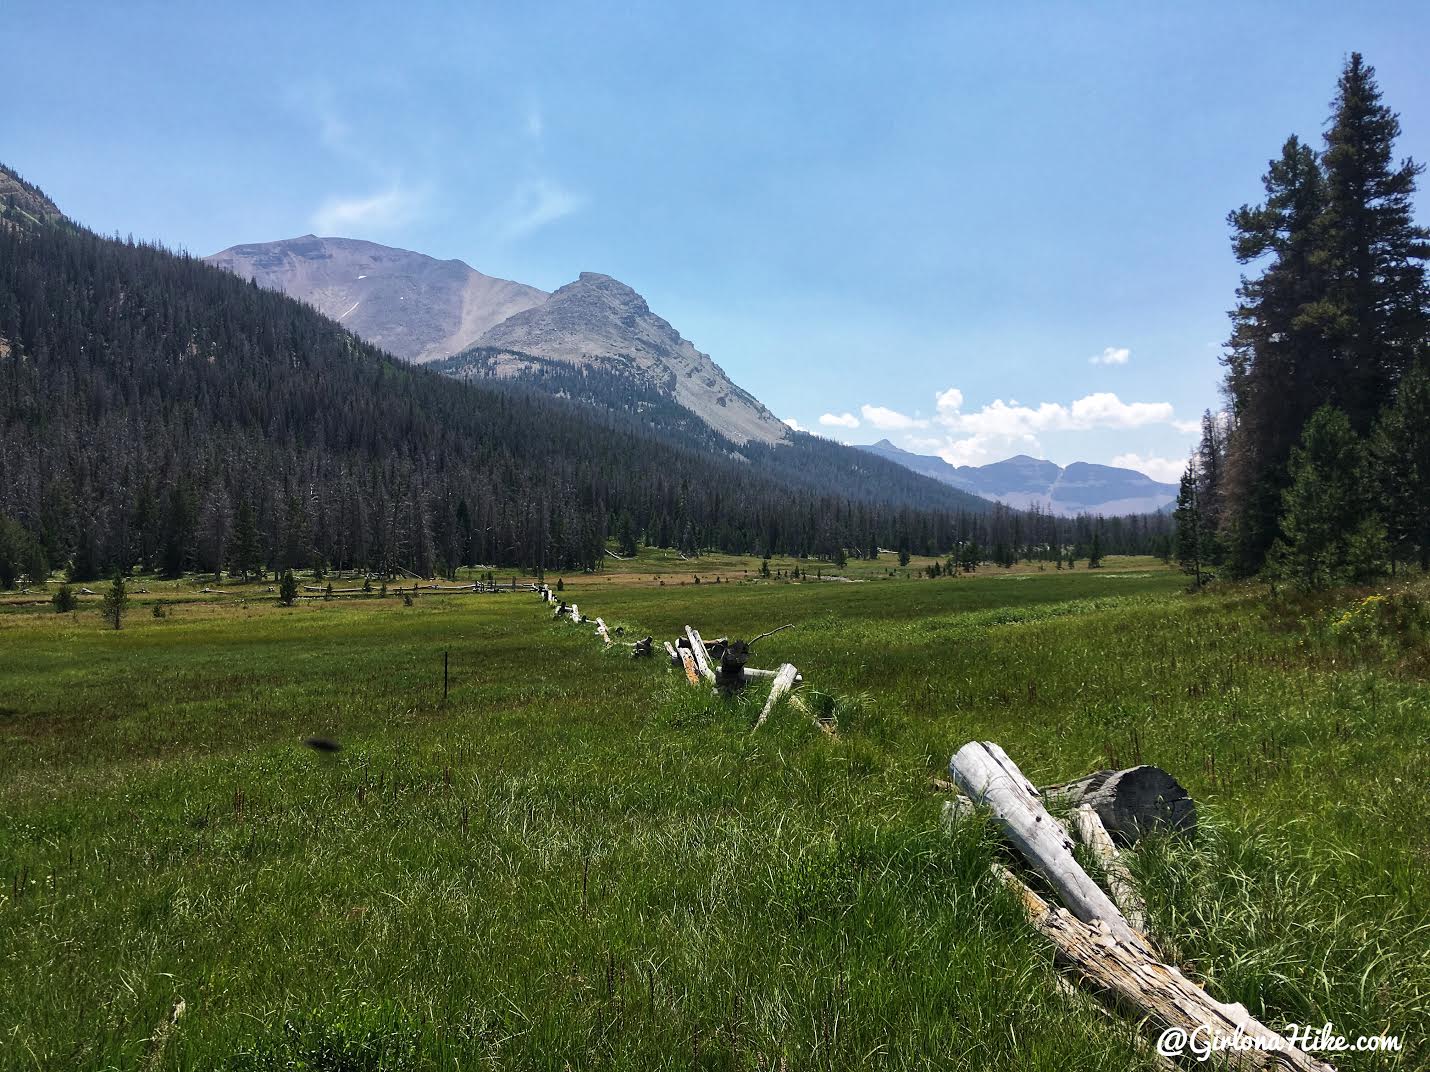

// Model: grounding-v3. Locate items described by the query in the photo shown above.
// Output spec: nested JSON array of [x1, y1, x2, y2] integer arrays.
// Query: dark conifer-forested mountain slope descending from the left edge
[[0, 167, 1012, 580]]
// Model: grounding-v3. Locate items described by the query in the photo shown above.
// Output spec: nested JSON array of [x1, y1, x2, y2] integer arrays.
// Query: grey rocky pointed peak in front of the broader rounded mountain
[[480, 272, 788, 443]]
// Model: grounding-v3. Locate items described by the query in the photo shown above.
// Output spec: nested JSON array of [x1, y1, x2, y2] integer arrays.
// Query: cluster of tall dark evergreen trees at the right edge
[[1175, 53, 1430, 589]]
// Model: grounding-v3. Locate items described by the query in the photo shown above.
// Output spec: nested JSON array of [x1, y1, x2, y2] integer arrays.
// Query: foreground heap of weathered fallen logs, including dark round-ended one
[[945, 740, 1334, 1072]]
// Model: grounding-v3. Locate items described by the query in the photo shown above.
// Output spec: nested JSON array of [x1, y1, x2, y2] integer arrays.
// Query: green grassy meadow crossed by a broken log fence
[[0, 553, 1430, 1072]]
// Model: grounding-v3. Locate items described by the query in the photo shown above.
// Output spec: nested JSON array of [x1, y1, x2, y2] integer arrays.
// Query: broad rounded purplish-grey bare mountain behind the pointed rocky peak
[[206, 234, 546, 362]]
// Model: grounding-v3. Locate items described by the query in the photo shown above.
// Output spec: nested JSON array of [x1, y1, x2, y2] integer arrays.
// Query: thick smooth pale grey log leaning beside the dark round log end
[[948, 740, 1137, 942]]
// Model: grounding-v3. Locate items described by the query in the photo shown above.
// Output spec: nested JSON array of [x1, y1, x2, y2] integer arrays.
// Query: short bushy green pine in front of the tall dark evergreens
[[1270, 406, 1386, 590]]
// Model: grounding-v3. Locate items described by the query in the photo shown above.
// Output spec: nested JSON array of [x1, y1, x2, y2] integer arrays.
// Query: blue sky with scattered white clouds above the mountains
[[0, 0, 1430, 480]]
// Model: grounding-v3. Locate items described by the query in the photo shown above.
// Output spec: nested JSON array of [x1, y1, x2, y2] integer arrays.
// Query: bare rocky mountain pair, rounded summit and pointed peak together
[[207, 234, 788, 445]]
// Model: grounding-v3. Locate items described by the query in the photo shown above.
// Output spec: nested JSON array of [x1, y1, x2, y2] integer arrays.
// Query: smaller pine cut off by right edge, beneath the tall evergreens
[[1370, 363, 1430, 570]]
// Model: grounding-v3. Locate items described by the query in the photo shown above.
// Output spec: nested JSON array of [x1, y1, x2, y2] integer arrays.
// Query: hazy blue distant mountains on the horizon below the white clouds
[[861, 439, 1177, 516]]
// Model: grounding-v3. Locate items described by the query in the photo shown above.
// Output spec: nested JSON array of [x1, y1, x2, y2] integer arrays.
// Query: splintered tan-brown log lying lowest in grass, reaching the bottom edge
[[994, 863, 1334, 1072]]
